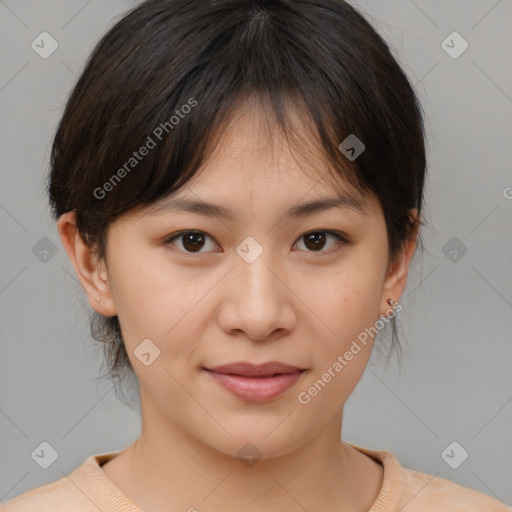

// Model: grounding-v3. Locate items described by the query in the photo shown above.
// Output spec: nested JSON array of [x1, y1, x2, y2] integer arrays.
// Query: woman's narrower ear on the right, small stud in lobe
[[380, 208, 419, 315]]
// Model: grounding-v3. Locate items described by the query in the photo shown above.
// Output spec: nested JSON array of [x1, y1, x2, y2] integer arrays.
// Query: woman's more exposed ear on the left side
[[57, 212, 117, 316]]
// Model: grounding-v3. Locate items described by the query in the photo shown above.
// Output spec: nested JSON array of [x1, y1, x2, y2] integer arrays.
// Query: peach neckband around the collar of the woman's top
[[76, 443, 402, 512]]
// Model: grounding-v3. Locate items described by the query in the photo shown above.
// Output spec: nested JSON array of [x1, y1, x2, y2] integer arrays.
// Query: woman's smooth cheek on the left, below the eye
[[107, 251, 224, 384]]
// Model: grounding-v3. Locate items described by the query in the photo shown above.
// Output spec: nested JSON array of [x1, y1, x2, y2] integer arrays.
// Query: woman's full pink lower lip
[[206, 370, 304, 402]]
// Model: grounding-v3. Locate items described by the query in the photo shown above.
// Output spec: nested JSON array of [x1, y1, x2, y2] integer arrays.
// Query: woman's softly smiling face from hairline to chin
[[62, 103, 414, 457]]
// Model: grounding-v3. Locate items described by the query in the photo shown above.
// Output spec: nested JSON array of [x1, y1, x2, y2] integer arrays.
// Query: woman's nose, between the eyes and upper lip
[[218, 246, 298, 341]]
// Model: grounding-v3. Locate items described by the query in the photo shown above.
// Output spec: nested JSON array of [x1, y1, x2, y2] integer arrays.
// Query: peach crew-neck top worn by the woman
[[0, 443, 512, 512]]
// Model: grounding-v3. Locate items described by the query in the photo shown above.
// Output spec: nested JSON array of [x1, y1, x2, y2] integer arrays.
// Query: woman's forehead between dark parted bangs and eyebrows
[[148, 103, 372, 218]]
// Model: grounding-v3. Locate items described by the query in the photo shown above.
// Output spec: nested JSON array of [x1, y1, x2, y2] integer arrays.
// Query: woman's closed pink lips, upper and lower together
[[203, 361, 306, 402]]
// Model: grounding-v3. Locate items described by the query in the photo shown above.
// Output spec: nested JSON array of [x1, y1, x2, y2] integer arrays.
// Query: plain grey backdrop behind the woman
[[0, 0, 512, 504]]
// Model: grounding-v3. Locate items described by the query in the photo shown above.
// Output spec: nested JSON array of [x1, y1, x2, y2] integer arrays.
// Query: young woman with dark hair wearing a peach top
[[2, 0, 507, 512]]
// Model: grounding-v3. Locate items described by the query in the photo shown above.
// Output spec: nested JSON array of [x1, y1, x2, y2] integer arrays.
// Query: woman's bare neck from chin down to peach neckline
[[105, 400, 380, 512]]
